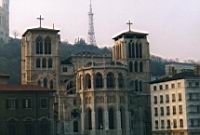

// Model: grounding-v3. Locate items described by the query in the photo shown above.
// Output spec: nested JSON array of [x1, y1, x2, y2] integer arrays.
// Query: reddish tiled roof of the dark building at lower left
[[0, 84, 53, 91]]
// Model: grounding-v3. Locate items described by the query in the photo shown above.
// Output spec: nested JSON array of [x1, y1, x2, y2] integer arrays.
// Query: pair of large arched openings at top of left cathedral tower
[[35, 36, 52, 55]]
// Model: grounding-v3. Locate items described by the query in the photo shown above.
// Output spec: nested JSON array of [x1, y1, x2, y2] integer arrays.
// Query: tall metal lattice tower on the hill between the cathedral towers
[[88, 0, 97, 46]]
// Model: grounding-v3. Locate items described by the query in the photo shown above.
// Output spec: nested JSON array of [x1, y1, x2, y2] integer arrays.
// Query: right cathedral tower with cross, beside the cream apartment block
[[112, 21, 151, 135]]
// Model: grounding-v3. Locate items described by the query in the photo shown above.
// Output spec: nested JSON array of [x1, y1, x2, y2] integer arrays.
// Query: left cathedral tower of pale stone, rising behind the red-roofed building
[[21, 20, 60, 90]]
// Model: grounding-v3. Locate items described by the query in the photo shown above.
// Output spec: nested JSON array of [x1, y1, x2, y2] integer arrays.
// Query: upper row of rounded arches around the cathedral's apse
[[77, 72, 126, 90]]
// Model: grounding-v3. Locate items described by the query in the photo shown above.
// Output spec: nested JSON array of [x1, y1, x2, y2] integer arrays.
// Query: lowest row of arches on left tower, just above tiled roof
[[37, 77, 54, 89]]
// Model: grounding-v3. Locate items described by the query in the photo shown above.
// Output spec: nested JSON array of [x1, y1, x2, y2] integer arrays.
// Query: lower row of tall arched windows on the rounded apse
[[84, 106, 127, 130]]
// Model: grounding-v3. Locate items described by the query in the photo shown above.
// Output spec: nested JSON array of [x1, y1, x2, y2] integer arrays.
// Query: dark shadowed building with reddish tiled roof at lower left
[[0, 84, 54, 135]]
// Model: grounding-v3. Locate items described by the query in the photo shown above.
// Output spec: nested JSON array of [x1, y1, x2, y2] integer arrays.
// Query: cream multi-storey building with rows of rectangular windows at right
[[151, 74, 200, 135]]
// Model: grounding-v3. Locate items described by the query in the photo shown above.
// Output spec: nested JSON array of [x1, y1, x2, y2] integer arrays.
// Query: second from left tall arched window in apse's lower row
[[97, 108, 104, 129]]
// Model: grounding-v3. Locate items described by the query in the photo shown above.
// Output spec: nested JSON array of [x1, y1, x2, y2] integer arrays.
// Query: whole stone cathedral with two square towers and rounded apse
[[21, 25, 151, 135]]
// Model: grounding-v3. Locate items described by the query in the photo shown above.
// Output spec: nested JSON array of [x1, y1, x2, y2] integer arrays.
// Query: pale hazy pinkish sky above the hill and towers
[[10, 0, 200, 60]]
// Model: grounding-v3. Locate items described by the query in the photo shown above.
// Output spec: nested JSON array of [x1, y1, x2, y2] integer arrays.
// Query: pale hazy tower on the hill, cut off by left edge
[[0, 0, 9, 42]]
